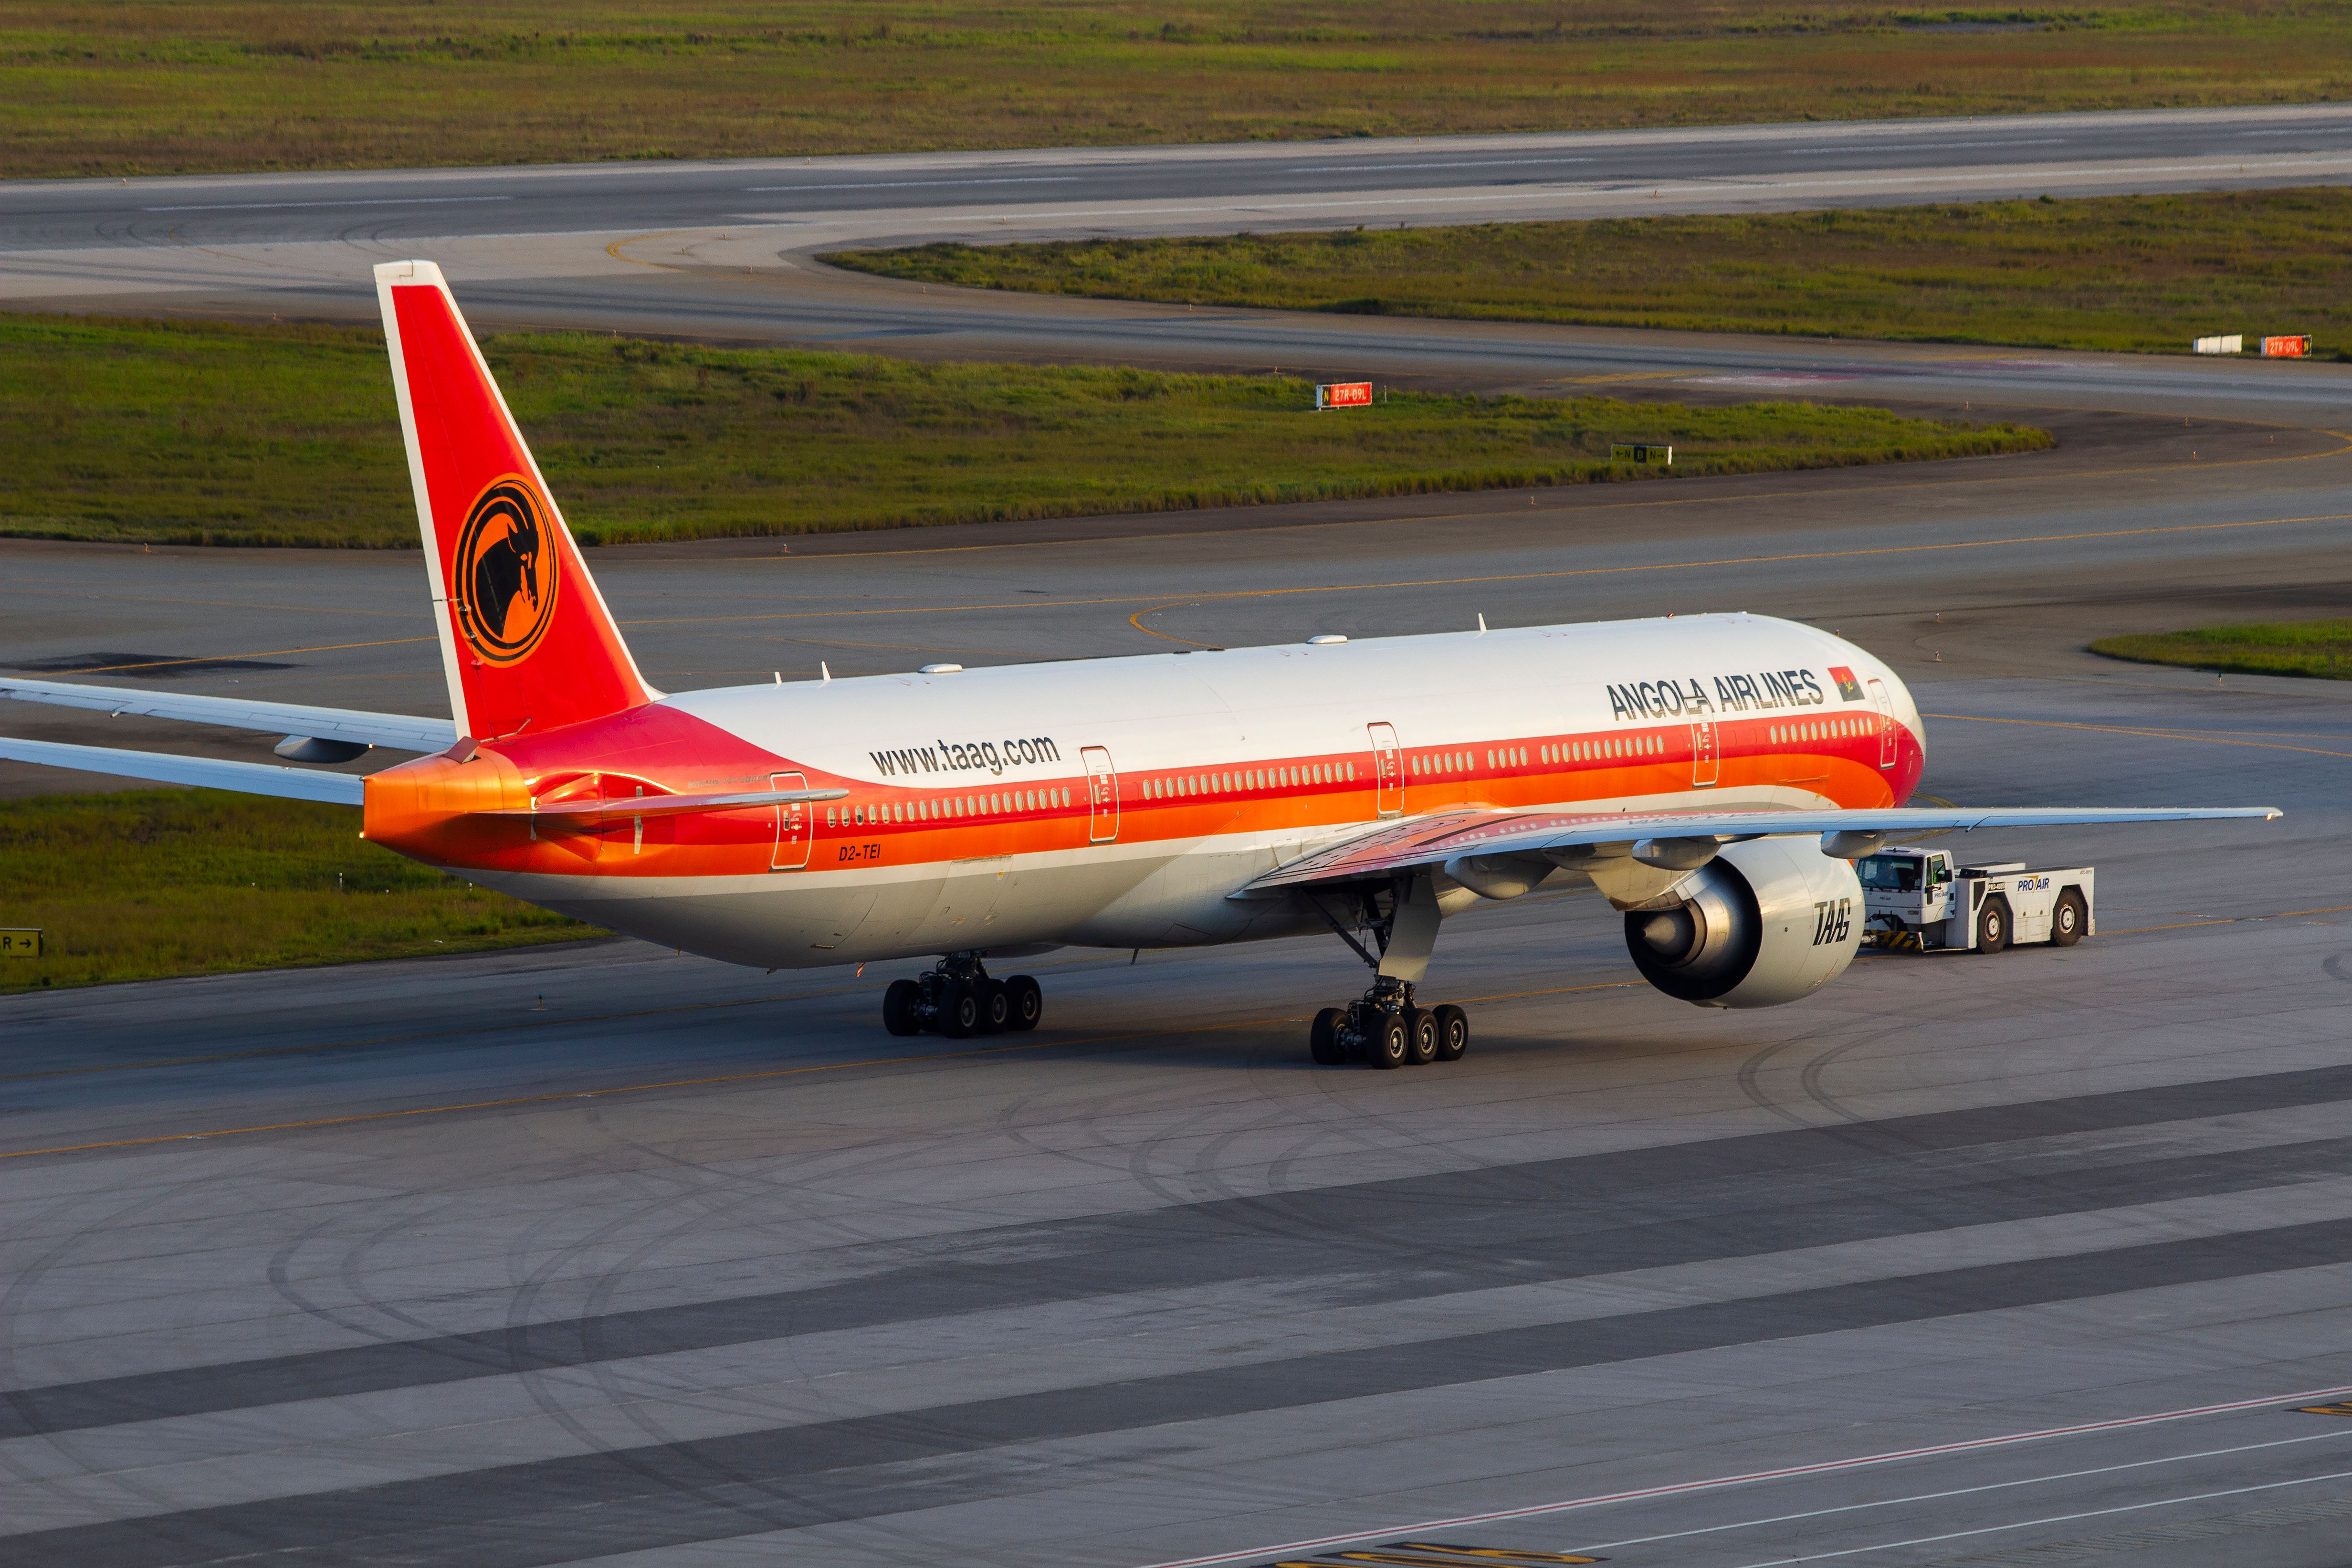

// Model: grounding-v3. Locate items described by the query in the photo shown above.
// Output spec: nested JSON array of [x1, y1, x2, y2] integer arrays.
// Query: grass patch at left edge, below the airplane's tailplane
[[0, 790, 598, 992]]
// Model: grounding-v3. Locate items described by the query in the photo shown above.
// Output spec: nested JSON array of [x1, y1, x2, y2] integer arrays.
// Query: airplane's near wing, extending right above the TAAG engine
[[1244, 806, 2284, 894]]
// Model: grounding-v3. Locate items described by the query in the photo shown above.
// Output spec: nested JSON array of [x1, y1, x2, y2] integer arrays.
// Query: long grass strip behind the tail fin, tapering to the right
[[0, 317, 2048, 548]]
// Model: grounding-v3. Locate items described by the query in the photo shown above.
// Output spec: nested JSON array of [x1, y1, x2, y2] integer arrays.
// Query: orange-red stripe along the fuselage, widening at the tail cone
[[365, 703, 1924, 877]]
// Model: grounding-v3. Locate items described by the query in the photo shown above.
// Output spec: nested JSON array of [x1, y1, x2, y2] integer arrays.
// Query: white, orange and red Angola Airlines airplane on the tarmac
[[0, 261, 2281, 1067]]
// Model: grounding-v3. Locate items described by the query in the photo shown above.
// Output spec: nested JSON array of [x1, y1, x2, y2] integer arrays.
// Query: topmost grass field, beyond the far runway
[[0, 0, 2352, 179]]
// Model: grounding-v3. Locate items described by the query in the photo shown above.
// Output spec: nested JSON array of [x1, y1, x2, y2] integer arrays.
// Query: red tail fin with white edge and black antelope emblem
[[376, 261, 651, 740]]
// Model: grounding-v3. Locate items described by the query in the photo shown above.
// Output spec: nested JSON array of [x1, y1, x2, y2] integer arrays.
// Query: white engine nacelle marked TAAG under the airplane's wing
[[1625, 837, 1863, 1006]]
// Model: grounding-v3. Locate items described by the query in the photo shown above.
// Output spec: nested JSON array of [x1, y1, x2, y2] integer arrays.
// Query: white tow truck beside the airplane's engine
[[1853, 844, 2096, 952]]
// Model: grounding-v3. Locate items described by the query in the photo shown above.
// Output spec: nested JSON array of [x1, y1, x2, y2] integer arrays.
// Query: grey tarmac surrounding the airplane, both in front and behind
[[0, 107, 2352, 1568]]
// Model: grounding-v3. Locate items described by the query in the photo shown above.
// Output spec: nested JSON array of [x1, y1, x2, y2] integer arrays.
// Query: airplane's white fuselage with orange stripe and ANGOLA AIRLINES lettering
[[466, 613, 1919, 966]]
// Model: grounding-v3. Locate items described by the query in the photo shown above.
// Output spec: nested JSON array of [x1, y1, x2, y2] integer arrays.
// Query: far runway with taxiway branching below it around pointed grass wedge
[[0, 104, 2352, 416]]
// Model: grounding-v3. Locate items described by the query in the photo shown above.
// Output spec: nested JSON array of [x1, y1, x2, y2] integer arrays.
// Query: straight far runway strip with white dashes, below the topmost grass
[[13, 104, 2352, 252]]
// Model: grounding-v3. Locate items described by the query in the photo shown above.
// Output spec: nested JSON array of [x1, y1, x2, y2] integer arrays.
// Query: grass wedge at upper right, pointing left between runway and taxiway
[[828, 188, 2352, 353]]
